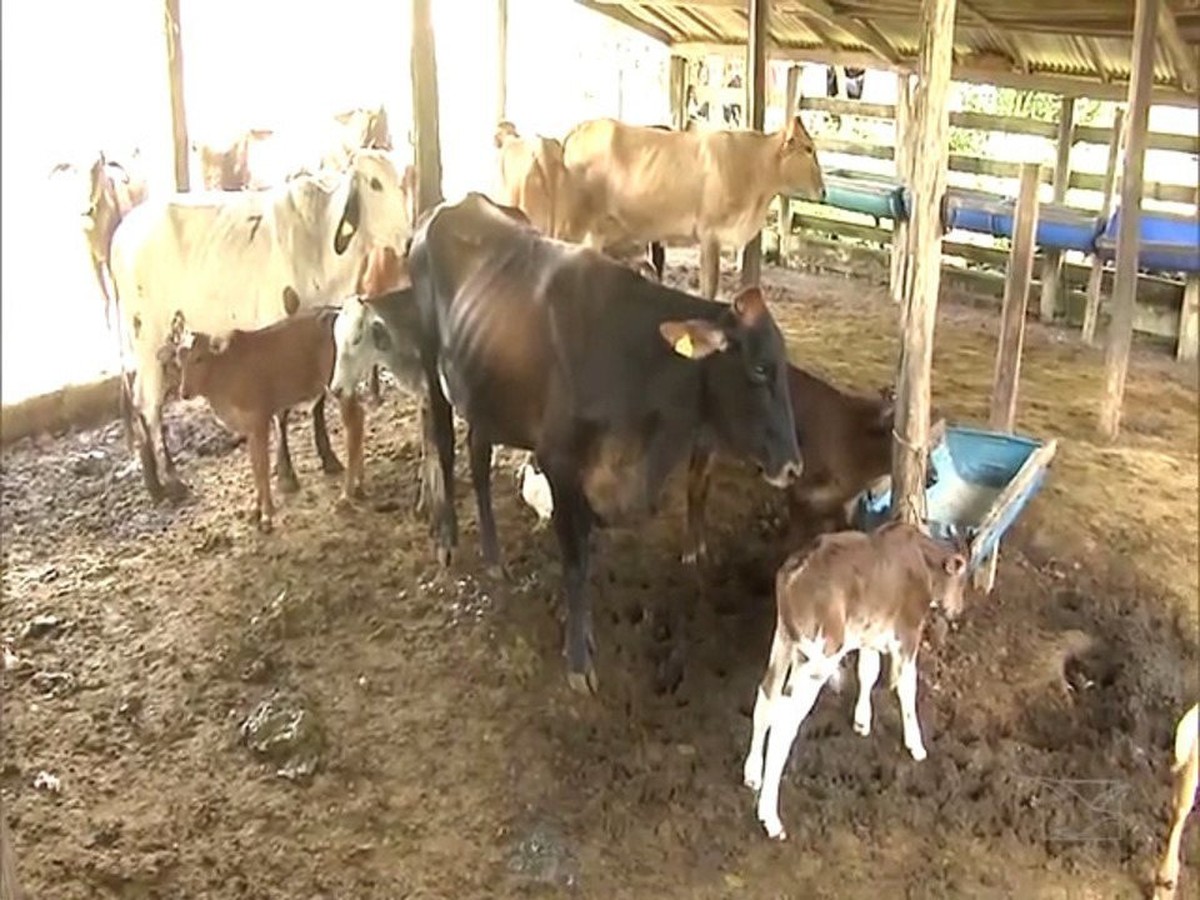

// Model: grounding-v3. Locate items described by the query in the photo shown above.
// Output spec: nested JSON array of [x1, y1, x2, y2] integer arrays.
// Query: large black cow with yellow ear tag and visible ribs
[[408, 193, 800, 691]]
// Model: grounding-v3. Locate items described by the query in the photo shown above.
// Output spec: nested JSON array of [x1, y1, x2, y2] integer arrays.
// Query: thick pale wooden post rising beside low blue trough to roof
[[892, 0, 956, 523]]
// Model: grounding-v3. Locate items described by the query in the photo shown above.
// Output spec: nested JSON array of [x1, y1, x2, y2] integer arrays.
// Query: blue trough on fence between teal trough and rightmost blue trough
[[942, 188, 1104, 253]]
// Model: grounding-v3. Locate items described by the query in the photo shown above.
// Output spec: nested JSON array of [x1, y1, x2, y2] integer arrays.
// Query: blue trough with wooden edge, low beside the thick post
[[854, 427, 1057, 571]]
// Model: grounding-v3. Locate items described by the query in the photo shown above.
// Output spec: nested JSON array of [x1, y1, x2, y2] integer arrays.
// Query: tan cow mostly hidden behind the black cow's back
[[496, 121, 568, 238]]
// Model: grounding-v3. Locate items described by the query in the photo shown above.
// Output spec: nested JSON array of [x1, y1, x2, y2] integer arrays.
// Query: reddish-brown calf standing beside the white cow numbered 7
[[173, 306, 362, 532]]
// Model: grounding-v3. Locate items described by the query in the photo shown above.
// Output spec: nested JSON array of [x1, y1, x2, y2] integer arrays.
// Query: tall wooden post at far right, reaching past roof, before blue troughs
[[1098, 0, 1159, 440]]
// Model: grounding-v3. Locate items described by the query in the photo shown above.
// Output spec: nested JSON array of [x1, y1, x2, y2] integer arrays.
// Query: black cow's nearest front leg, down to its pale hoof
[[539, 480, 600, 694]]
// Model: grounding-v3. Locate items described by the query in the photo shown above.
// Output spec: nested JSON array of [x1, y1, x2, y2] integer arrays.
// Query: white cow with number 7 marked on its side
[[112, 150, 413, 498]]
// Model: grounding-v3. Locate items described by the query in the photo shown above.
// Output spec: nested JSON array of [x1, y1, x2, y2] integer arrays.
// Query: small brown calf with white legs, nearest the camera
[[743, 522, 967, 840]]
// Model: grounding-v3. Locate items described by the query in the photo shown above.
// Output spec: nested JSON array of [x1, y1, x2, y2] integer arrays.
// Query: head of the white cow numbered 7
[[334, 150, 414, 256]]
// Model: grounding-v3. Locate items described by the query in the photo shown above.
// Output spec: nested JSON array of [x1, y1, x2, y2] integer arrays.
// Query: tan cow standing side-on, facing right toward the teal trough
[[563, 116, 824, 298]]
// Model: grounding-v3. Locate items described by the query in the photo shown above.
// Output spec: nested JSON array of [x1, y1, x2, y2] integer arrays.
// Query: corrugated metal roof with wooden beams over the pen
[[576, 0, 1200, 103]]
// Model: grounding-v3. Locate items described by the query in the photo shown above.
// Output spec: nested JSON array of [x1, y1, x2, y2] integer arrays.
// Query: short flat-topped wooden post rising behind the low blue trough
[[974, 163, 1042, 593]]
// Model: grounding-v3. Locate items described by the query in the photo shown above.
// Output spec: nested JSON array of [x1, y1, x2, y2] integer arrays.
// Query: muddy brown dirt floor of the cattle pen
[[7, 260, 1200, 900]]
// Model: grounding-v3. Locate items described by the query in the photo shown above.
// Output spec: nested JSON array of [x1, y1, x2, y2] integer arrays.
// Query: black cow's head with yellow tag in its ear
[[659, 288, 802, 487]]
